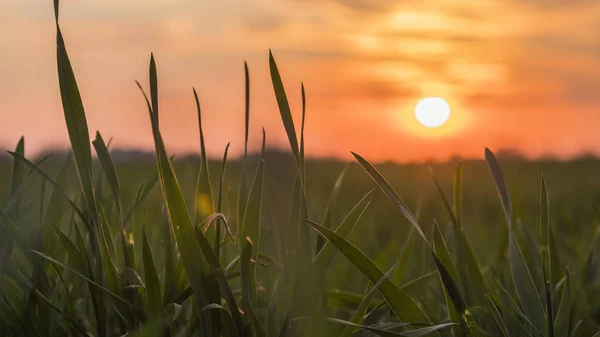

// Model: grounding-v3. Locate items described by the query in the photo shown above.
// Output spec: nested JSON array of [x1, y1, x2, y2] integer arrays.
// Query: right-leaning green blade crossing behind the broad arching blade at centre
[[313, 190, 373, 277]]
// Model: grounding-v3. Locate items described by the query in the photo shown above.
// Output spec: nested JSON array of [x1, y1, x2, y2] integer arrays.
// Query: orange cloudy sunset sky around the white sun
[[0, 0, 600, 161]]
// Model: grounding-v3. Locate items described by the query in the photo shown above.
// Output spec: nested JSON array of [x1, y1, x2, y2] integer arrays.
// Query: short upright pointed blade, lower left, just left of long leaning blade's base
[[142, 227, 163, 317]]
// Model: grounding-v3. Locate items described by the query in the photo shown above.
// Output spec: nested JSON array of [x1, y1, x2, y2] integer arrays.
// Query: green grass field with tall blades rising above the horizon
[[0, 1, 600, 337]]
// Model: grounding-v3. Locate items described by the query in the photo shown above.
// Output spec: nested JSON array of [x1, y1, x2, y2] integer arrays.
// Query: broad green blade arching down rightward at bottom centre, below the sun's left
[[308, 220, 429, 322]]
